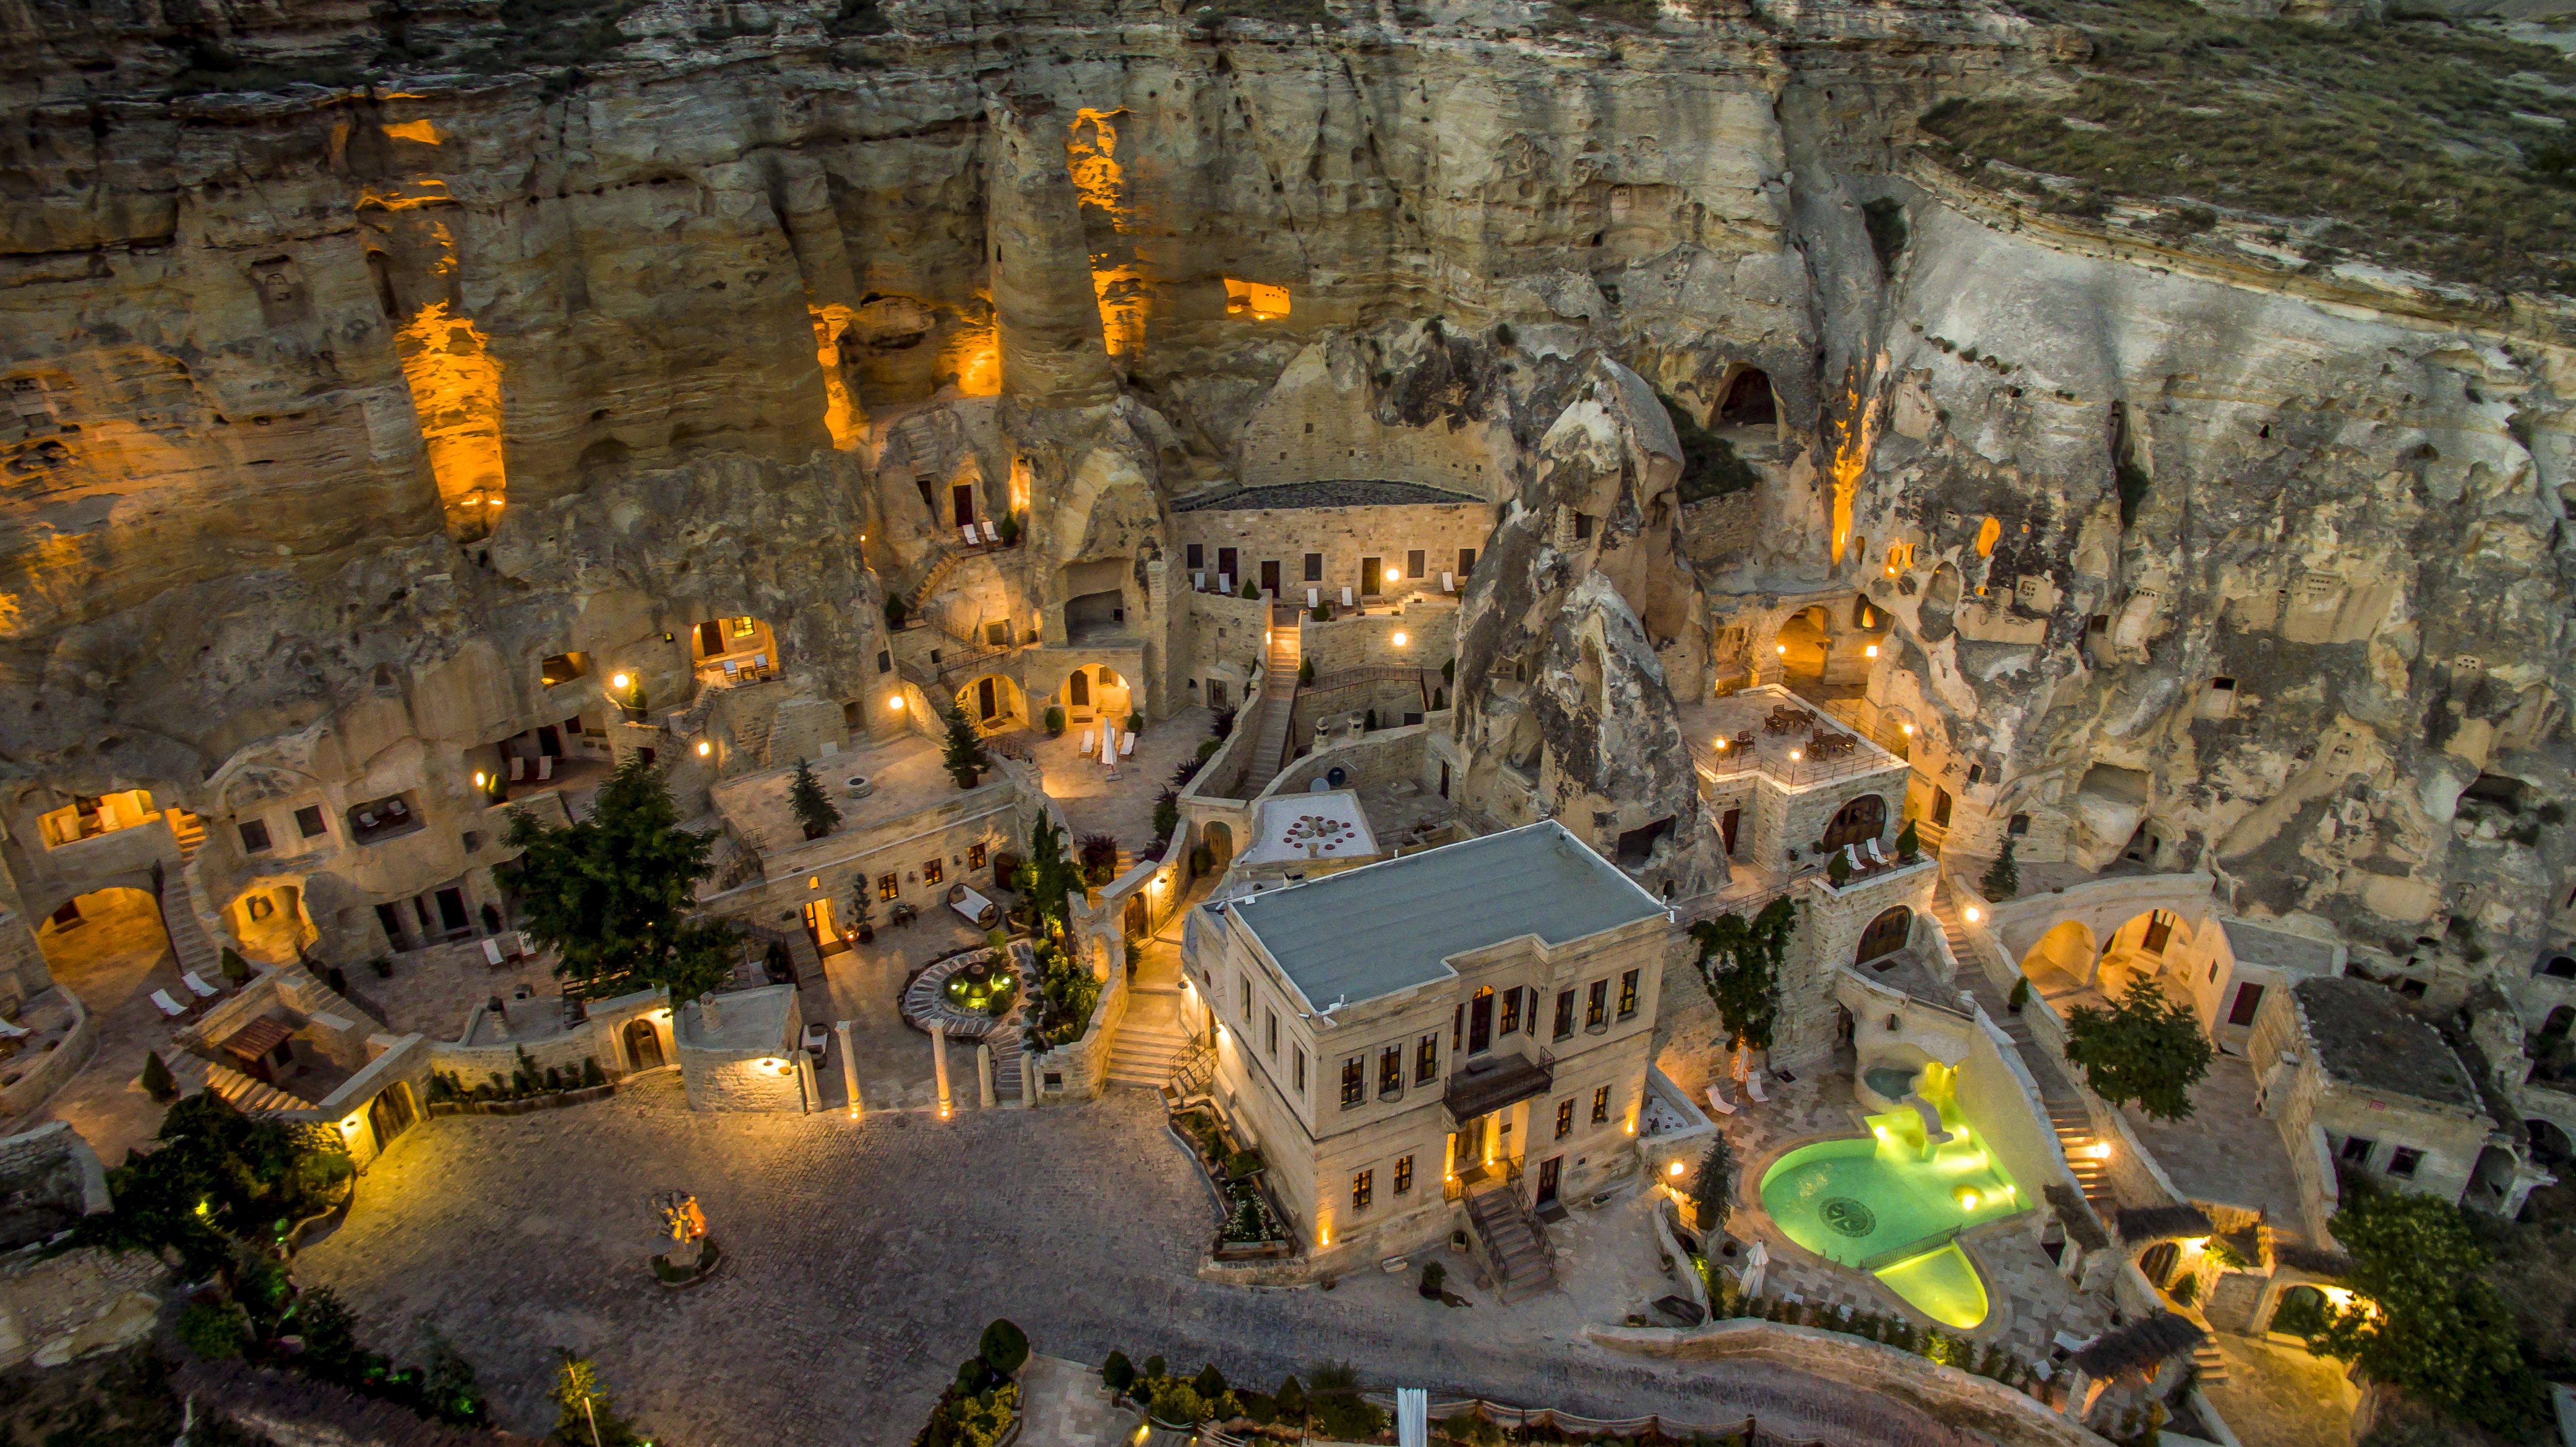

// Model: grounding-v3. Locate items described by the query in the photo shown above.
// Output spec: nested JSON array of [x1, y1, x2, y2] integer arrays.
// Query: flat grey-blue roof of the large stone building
[[1229, 821, 1664, 1009]]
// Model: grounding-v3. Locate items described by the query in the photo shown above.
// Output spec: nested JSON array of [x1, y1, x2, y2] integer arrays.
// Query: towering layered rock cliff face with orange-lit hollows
[[0, 0, 2576, 1004]]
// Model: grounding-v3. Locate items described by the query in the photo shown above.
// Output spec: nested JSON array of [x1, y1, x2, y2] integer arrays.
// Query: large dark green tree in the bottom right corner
[[2308, 1187, 2545, 1439]]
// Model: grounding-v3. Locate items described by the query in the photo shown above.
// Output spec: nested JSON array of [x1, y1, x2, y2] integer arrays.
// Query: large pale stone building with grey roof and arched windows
[[1185, 821, 1672, 1290]]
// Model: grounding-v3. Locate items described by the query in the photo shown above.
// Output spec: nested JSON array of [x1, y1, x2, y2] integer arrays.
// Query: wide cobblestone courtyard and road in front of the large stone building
[[299, 1076, 1989, 1447]]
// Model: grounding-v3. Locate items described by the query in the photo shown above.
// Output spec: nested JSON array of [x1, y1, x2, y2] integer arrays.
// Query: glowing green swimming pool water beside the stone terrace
[[1762, 1081, 2025, 1328]]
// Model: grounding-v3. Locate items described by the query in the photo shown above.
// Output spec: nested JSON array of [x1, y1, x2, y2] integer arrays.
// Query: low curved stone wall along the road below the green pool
[[1584, 1318, 2110, 1447]]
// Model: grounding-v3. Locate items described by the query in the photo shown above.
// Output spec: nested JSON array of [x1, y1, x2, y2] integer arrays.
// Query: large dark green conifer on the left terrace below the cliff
[[495, 754, 734, 1002]]
